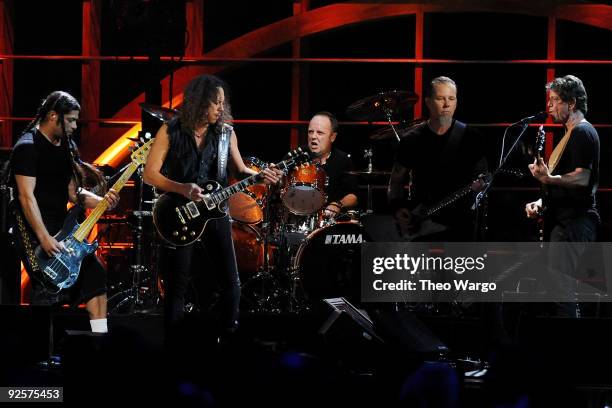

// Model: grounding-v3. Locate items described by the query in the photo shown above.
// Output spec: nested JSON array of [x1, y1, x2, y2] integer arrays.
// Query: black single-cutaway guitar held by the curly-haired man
[[153, 148, 309, 246]]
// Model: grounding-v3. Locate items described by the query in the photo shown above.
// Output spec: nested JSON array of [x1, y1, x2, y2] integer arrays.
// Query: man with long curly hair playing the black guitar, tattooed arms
[[144, 75, 282, 335]]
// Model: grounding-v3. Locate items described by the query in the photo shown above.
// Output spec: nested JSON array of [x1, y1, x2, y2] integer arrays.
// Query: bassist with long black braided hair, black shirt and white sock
[[10, 91, 119, 333]]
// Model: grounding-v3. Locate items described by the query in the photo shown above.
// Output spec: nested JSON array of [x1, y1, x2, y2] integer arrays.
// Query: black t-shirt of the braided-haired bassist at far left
[[11, 130, 73, 230]]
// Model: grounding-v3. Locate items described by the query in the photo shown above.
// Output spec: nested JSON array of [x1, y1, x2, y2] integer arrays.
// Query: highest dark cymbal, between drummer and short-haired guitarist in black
[[346, 90, 419, 122]]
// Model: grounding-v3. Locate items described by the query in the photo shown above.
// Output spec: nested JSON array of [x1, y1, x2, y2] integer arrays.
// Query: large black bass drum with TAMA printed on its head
[[293, 220, 370, 303]]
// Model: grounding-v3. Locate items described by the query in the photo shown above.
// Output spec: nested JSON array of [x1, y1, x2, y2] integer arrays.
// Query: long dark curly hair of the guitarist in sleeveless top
[[179, 75, 232, 134]]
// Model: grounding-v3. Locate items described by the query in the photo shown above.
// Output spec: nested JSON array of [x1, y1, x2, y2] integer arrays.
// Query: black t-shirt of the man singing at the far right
[[545, 122, 599, 220]]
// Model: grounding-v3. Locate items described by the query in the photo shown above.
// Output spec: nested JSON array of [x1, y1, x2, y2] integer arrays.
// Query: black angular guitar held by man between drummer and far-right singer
[[397, 175, 491, 241]]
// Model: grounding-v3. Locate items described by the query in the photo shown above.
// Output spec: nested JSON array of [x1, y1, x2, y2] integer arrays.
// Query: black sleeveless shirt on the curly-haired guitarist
[[162, 117, 229, 186]]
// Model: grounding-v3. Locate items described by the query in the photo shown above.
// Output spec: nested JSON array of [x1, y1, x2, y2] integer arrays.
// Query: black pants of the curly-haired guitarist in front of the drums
[[163, 217, 240, 330]]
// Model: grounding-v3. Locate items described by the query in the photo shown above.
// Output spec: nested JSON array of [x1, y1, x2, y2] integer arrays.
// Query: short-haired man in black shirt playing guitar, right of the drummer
[[387, 76, 487, 241]]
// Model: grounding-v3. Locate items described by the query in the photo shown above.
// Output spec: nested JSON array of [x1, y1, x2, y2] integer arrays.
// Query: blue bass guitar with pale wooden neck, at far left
[[13, 139, 154, 292]]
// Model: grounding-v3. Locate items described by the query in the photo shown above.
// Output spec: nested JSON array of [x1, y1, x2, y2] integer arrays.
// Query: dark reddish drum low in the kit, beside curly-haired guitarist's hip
[[232, 221, 273, 282]]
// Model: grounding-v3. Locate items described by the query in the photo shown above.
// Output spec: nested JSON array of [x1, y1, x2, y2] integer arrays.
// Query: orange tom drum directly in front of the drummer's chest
[[281, 164, 328, 215]]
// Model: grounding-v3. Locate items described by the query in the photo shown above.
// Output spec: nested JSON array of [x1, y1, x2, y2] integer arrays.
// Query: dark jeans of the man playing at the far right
[[547, 215, 597, 317]]
